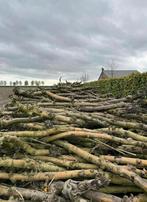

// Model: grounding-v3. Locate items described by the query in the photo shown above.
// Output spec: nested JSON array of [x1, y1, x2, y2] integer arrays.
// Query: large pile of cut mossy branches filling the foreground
[[0, 83, 147, 202]]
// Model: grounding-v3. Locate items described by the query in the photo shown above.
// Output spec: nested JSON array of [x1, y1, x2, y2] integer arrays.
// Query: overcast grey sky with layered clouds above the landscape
[[0, 0, 147, 83]]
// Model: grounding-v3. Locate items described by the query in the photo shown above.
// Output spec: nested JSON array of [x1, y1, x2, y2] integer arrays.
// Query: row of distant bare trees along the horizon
[[0, 80, 44, 86]]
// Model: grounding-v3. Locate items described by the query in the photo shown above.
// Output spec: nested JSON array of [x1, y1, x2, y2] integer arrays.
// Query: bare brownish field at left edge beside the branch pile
[[0, 86, 13, 107]]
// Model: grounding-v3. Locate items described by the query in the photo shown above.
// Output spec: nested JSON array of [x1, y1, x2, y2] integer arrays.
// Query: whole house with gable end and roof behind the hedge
[[98, 68, 140, 80]]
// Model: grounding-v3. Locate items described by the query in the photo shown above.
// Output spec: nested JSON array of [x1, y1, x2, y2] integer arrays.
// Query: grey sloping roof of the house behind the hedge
[[103, 70, 139, 78]]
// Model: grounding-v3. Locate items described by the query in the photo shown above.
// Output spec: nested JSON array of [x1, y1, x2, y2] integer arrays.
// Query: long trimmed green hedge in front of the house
[[83, 73, 147, 97]]
